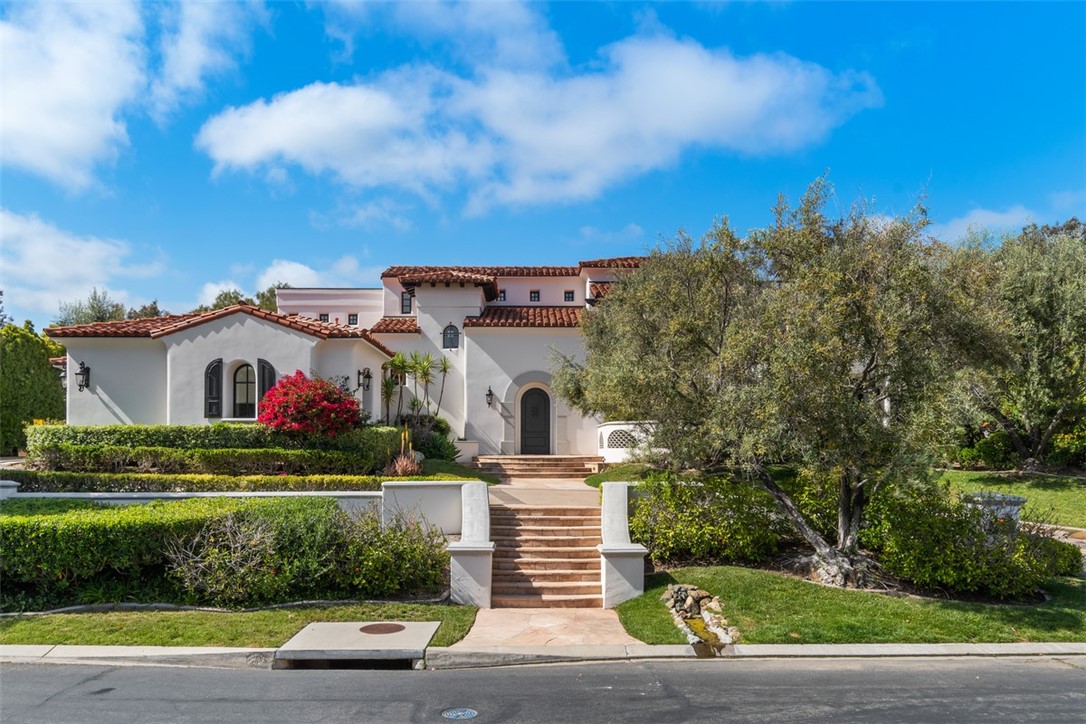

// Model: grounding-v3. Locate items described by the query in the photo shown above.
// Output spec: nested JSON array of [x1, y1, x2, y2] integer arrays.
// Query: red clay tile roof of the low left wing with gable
[[46, 304, 393, 357]]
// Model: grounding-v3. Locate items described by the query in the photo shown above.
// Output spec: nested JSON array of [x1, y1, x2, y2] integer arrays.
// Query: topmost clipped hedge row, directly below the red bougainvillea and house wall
[[26, 422, 400, 455]]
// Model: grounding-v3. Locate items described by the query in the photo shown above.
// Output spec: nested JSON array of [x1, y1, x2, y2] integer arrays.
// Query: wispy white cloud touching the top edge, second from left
[[150, 2, 263, 122]]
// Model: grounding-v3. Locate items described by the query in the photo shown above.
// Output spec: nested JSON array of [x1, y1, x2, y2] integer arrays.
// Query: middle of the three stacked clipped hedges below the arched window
[[26, 443, 384, 475]]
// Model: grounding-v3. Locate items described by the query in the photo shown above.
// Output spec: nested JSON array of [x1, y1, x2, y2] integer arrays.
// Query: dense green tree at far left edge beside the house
[[0, 322, 64, 454]]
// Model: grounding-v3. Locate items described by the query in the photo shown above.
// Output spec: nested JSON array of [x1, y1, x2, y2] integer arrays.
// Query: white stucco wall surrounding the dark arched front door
[[465, 327, 599, 455]]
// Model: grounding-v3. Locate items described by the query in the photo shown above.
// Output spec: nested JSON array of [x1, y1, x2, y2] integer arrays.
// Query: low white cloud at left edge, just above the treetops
[[0, 209, 165, 318]]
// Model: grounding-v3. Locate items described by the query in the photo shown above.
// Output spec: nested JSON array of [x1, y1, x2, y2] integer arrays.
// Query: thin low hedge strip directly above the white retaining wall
[[3, 470, 463, 493]]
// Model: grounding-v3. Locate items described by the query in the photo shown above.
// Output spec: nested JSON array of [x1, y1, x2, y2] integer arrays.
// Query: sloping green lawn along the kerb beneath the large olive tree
[[618, 566, 1086, 644]]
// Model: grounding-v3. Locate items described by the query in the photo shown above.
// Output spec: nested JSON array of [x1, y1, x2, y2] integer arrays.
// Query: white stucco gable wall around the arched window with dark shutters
[[161, 312, 317, 424]]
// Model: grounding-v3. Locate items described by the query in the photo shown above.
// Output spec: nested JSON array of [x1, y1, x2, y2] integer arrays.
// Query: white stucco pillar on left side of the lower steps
[[449, 482, 494, 608]]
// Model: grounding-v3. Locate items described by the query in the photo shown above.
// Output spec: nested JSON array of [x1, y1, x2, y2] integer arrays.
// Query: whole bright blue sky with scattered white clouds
[[0, 1, 1086, 328]]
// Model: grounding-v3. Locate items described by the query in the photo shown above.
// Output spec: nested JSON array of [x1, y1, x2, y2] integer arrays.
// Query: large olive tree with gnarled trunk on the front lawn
[[555, 180, 987, 585]]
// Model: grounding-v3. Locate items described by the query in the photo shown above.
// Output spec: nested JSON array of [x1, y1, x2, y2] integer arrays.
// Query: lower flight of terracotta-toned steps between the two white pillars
[[490, 505, 603, 608]]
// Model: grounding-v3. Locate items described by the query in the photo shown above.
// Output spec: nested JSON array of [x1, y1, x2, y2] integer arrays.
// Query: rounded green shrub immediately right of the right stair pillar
[[630, 475, 782, 563]]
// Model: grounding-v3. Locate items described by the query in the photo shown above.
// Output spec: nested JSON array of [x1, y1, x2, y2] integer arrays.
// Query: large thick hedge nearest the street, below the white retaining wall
[[0, 498, 449, 608]]
